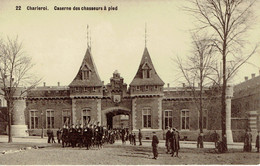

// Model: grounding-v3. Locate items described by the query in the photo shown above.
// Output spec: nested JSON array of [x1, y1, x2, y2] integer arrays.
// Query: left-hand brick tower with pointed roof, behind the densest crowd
[[69, 26, 103, 124]]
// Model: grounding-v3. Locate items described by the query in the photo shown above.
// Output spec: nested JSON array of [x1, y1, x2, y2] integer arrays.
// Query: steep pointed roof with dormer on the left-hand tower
[[69, 47, 103, 87]]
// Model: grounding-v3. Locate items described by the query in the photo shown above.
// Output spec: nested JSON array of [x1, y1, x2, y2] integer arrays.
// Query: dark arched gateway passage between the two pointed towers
[[101, 107, 132, 129]]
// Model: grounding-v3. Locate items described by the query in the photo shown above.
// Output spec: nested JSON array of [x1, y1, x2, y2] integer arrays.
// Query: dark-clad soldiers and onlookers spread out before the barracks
[[47, 123, 260, 159]]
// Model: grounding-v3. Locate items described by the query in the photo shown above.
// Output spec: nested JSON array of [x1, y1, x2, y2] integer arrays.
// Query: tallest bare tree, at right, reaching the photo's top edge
[[186, 0, 257, 149]]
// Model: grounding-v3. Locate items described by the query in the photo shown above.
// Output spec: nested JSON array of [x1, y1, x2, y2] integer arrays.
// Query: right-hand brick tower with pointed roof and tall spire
[[129, 26, 164, 132]]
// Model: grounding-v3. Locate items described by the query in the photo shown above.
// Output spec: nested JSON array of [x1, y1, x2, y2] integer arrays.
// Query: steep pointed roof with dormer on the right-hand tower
[[130, 47, 164, 86]]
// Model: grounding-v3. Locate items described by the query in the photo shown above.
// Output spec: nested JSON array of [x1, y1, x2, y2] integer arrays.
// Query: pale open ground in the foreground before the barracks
[[0, 141, 260, 165]]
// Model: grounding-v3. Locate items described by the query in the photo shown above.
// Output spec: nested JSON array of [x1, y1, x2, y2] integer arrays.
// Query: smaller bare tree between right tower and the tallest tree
[[176, 34, 220, 146]]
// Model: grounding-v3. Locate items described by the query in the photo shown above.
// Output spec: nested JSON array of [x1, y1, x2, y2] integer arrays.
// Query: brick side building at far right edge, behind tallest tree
[[231, 71, 260, 142]]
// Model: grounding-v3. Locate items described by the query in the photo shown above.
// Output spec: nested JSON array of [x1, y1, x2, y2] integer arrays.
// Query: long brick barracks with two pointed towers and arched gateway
[[2, 43, 260, 141]]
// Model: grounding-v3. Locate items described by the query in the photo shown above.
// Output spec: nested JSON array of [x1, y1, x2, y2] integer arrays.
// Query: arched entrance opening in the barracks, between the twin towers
[[102, 107, 132, 130]]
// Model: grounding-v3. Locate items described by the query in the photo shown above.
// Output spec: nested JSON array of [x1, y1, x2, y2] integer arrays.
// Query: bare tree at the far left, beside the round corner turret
[[0, 37, 41, 142]]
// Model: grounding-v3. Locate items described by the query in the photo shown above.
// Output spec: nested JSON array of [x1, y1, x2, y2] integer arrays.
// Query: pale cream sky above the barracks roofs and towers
[[0, 0, 260, 86]]
